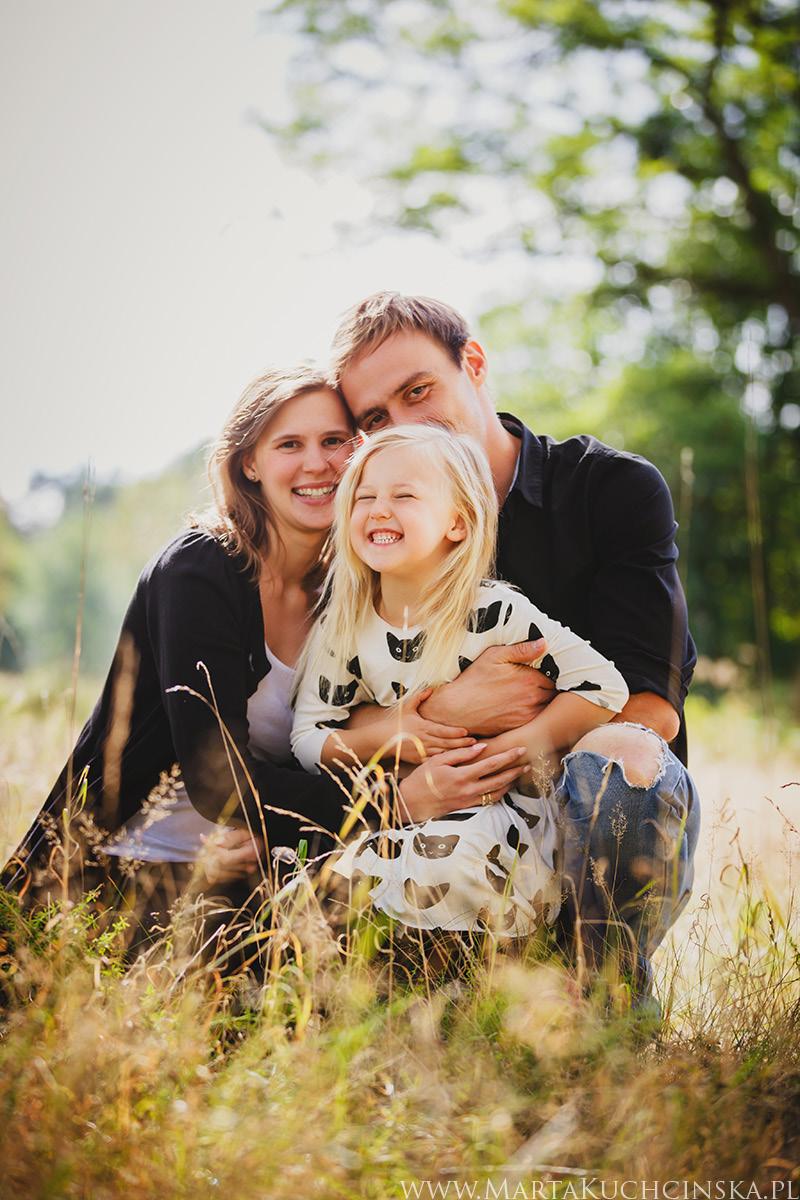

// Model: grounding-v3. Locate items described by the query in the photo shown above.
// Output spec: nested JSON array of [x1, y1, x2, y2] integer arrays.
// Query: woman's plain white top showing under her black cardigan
[[103, 643, 295, 863]]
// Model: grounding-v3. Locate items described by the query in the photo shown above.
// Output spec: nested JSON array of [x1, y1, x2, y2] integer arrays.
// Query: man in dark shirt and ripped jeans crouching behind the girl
[[332, 292, 699, 995]]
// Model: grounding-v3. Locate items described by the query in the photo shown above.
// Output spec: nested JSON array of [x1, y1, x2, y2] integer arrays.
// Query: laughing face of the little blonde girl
[[350, 446, 467, 584]]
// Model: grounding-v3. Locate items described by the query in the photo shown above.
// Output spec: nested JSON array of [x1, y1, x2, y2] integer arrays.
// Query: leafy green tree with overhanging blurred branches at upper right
[[265, 0, 800, 681]]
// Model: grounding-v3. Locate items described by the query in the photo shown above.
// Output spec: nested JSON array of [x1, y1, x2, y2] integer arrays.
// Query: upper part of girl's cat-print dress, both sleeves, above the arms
[[291, 580, 628, 770]]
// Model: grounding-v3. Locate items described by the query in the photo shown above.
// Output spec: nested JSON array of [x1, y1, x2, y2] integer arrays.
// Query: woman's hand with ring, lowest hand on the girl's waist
[[399, 743, 525, 821]]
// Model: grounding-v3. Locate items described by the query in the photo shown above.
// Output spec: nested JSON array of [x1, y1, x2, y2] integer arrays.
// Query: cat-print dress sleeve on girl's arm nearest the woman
[[291, 626, 374, 772]]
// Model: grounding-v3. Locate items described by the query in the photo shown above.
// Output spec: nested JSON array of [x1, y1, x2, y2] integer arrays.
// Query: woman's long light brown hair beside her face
[[199, 362, 340, 575]]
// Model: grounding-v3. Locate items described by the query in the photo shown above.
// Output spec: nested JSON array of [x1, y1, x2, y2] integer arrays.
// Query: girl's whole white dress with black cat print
[[291, 581, 628, 937]]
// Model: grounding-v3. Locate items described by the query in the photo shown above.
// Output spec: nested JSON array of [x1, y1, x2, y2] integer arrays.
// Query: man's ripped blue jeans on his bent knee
[[555, 730, 700, 995]]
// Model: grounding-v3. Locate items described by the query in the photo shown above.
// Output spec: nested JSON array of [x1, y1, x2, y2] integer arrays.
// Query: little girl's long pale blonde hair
[[309, 425, 498, 690]]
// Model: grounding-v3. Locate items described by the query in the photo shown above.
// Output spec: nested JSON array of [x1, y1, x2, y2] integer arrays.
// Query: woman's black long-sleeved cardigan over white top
[[6, 529, 345, 882]]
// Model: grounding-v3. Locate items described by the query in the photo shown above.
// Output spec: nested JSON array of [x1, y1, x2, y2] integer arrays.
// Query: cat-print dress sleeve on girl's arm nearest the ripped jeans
[[482, 584, 628, 713]]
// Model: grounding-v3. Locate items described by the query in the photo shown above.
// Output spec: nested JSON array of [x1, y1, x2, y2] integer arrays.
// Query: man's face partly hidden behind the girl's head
[[339, 331, 486, 444]]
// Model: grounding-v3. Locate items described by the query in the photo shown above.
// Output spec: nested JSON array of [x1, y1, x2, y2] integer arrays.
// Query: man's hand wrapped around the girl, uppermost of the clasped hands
[[420, 637, 555, 737]]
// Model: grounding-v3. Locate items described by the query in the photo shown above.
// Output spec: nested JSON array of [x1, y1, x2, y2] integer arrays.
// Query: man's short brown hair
[[331, 292, 469, 388]]
